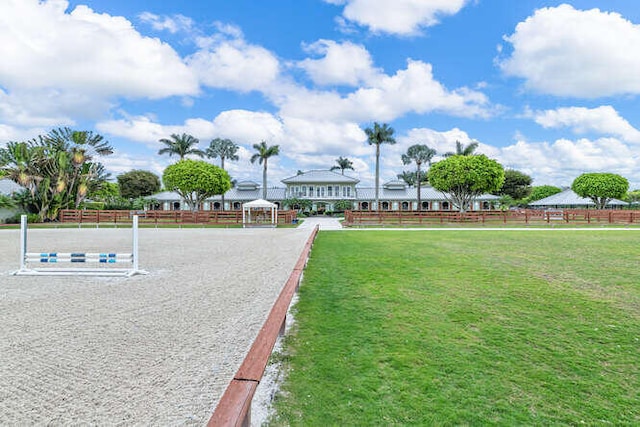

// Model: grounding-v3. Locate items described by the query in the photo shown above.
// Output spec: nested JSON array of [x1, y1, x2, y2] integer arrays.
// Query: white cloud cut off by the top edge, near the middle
[[324, 0, 466, 36]]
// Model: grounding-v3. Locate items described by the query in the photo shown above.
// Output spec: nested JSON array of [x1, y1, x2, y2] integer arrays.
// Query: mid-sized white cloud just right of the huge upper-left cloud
[[187, 24, 280, 92]]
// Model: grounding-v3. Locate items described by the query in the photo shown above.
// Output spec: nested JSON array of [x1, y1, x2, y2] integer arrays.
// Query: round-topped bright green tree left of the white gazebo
[[162, 159, 231, 212]]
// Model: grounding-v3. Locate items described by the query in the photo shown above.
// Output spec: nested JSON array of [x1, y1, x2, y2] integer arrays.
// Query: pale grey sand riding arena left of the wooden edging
[[0, 228, 311, 425]]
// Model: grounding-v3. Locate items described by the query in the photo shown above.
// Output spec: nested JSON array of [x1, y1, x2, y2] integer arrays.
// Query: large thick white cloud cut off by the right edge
[[499, 4, 640, 98]]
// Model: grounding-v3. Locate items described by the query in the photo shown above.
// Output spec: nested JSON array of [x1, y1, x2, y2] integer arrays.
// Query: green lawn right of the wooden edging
[[272, 230, 640, 426]]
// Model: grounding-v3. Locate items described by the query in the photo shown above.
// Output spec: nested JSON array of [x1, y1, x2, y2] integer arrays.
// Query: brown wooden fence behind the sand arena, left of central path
[[58, 209, 296, 225]]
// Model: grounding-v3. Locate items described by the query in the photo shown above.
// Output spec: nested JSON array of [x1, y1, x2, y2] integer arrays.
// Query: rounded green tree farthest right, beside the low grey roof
[[571, 172, 629, 209]]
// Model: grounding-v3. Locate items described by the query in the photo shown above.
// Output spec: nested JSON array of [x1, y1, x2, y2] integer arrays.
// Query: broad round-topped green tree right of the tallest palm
[[429, 154, 504, 212]]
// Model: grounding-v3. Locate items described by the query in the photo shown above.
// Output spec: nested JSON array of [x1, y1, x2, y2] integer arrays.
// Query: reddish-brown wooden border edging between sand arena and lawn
[[207, 225, 319, 427]]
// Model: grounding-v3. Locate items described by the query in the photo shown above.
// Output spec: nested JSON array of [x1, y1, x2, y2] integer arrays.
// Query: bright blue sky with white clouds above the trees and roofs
[[0, 0, 640, 188]]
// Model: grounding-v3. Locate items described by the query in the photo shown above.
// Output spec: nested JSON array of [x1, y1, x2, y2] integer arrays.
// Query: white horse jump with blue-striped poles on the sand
[[13, 215, 147, 276]]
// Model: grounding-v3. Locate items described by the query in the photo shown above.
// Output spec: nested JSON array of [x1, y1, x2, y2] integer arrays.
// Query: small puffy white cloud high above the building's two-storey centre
[[298, 40, 380, 86]]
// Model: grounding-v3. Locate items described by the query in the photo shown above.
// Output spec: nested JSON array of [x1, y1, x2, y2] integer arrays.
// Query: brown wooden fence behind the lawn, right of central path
[[342, 209, 640, 227]]
